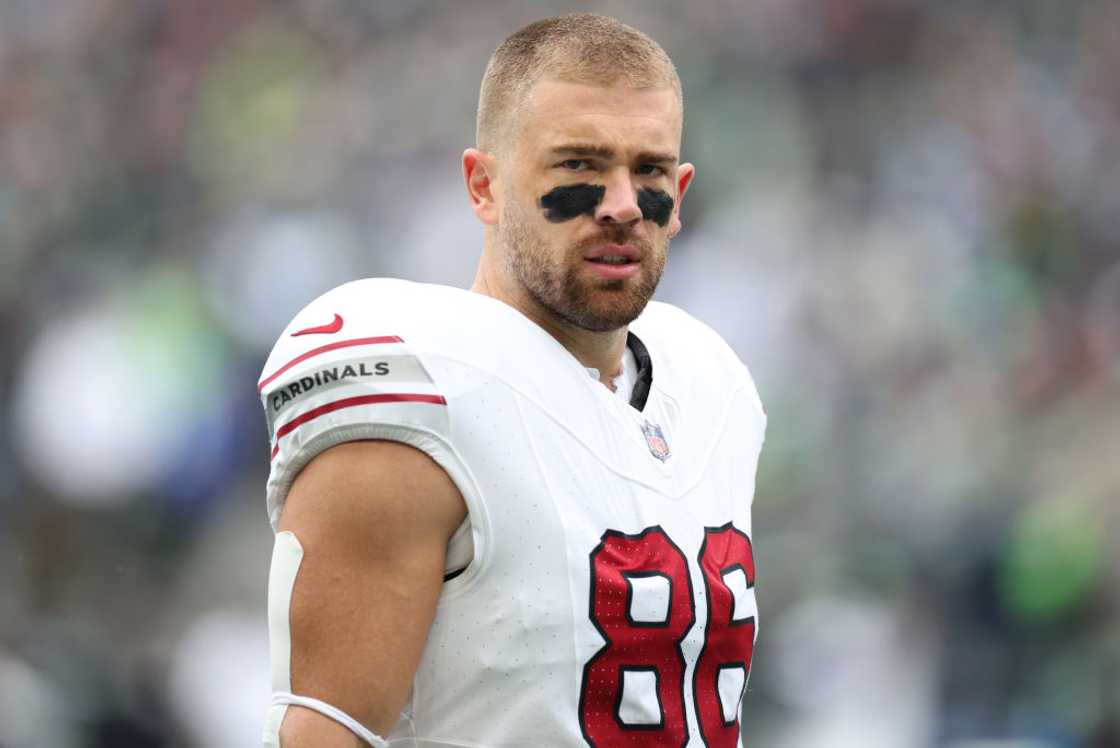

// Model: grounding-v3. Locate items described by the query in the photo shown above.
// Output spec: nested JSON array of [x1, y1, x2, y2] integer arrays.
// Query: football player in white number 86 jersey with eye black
[[260, 15, 766, 748]]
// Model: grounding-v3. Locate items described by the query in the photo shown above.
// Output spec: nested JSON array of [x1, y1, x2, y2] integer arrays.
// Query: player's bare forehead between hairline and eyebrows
[[520, 80, 681, 152]]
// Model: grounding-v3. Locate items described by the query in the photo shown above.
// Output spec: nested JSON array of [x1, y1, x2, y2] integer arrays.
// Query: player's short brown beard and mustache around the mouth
[[498, 200, 669, 333]]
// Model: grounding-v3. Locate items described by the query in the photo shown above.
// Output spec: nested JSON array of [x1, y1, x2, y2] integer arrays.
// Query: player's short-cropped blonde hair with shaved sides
[[475, 13, 683, 152]]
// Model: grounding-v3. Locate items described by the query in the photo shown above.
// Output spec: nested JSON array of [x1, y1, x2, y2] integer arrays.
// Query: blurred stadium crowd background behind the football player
[[0, 0, 1120, 748]]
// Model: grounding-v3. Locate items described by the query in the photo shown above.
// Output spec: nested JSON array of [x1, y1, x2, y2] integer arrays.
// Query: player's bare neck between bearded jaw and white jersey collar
[[470, 258, 627, 391]]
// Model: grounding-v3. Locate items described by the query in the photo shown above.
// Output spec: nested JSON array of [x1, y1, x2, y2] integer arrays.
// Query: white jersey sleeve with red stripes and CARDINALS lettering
[[258, 281, 454, 530]]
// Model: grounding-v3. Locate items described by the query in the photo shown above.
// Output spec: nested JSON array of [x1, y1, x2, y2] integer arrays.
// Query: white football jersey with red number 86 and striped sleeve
[[260, 279, 766, 748]]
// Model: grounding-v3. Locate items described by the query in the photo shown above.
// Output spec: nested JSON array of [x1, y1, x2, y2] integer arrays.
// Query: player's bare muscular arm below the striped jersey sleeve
[[278, 441, 466, 748]]
